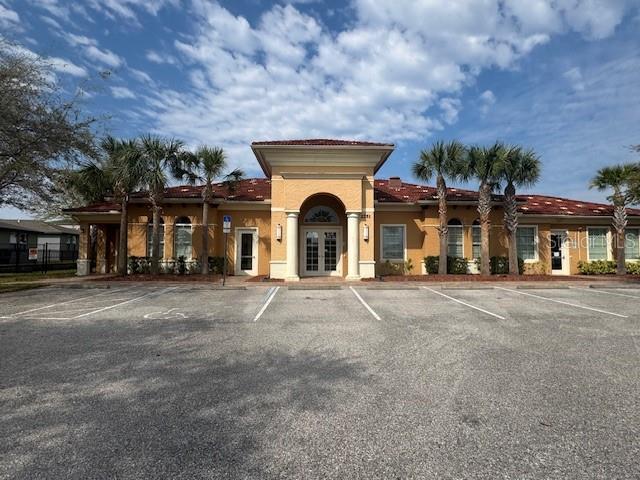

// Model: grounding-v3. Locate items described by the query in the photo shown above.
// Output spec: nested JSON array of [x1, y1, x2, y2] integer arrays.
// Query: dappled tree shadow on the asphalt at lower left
[[0, 320, 371, 479]]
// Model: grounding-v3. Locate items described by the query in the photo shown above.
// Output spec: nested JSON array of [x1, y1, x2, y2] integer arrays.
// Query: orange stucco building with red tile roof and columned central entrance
[[63, 140, 640, 280]]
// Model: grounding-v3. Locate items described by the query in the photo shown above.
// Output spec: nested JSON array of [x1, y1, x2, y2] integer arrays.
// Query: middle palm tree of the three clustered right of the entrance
[[461, 142, 507, 275]]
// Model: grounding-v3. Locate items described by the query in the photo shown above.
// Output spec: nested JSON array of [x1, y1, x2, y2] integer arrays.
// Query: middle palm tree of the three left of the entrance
[[136, 135, 187, 275]]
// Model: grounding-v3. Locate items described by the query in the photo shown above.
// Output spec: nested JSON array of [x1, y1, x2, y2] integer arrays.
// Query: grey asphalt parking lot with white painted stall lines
[[0, 284, 640, 479]]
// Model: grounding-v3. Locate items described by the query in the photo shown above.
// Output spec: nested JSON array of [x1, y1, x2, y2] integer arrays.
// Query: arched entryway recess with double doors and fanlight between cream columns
[[298, 193, 346, 277]]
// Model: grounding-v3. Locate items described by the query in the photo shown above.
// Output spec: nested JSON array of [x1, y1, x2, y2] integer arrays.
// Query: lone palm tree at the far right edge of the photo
[[589, 163, 640, 275]]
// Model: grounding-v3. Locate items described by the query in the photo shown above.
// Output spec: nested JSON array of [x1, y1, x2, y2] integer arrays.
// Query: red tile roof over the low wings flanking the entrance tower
[[67, 178, 640, 217]]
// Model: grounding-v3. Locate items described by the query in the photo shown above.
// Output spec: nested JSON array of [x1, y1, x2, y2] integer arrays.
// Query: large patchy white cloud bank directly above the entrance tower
[[130, 0, 631, 170]]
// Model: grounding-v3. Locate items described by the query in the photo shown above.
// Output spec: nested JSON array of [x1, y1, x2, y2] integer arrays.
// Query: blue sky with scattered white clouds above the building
[[0, 0, 640, 217]]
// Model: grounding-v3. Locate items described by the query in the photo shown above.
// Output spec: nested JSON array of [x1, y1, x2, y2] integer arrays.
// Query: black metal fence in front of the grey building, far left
[[0, 243, 78, 273]]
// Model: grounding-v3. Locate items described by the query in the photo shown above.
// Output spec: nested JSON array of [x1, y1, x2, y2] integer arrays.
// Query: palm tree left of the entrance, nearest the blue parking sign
[[179, 146, 226, 275]]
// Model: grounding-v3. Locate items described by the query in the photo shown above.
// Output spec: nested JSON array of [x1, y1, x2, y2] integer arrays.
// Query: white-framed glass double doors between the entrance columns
[[300, 228, 342, 276]]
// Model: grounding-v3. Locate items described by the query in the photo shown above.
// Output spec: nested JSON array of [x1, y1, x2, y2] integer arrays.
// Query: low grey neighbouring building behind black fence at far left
[[0, 220, 80, 271]]
